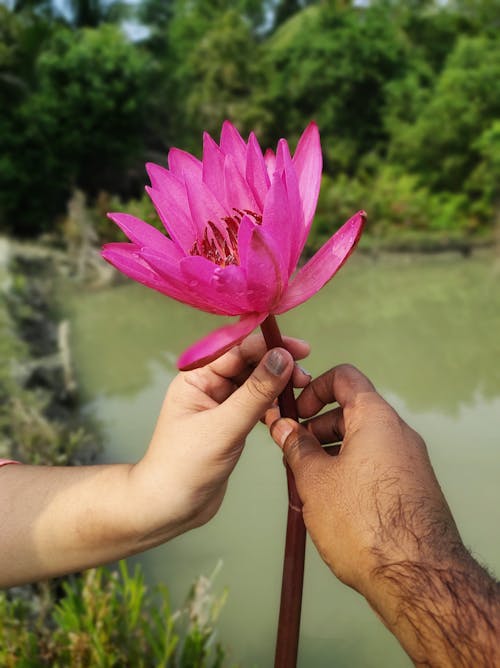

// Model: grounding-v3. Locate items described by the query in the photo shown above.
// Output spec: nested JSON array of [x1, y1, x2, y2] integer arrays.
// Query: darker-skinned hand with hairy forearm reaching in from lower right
[[266, 365, 500, 667]]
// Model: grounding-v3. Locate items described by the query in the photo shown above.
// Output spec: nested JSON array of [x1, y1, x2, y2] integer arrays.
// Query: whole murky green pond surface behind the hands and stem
[[64, 255, 500, 668]]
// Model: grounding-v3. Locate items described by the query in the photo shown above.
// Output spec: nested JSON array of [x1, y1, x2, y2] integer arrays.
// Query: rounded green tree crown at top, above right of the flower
[[265, 3, 409, 173]]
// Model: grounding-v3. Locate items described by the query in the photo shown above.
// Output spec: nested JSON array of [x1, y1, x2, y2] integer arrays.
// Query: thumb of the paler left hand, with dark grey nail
[[215, 348, 294, 439]]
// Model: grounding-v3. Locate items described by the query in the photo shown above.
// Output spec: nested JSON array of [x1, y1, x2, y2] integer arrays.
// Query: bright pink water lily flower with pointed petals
[[102, 121, 365, 369]]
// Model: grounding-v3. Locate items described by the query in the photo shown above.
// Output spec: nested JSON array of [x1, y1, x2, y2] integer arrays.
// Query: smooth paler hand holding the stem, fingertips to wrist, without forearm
[[131, 336, 310, 541]]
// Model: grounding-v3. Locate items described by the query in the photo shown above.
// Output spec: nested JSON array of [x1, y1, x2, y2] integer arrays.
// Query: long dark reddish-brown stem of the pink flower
[[261, 315, 306, 668]]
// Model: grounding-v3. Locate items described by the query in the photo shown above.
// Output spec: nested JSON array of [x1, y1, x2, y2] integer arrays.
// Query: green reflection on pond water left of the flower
[[63, 282, 220, 398]]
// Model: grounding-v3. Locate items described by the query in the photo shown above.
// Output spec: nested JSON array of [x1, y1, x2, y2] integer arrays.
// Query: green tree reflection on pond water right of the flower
[[284, 257, 500, 415]]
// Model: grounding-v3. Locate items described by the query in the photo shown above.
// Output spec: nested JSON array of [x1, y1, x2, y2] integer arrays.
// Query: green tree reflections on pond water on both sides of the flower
[[68, 252, 500, 415]]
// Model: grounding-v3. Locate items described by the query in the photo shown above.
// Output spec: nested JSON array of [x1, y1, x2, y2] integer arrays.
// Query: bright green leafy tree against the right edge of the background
[[390, 36, 500, 192]]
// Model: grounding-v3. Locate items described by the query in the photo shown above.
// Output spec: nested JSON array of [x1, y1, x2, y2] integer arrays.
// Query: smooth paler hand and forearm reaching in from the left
[[0, 336, 310, 587]]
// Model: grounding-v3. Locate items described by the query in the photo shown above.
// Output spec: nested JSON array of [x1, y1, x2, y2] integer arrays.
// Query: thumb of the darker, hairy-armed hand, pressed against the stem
[[270, 418, 331, 488]]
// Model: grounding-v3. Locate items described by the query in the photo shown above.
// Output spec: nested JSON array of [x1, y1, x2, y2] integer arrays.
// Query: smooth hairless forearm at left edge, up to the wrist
[[0, 465, 181, 587]]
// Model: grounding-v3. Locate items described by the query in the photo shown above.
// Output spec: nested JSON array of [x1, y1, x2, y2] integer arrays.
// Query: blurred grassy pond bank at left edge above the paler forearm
[[0, 238, 99, 464]]
